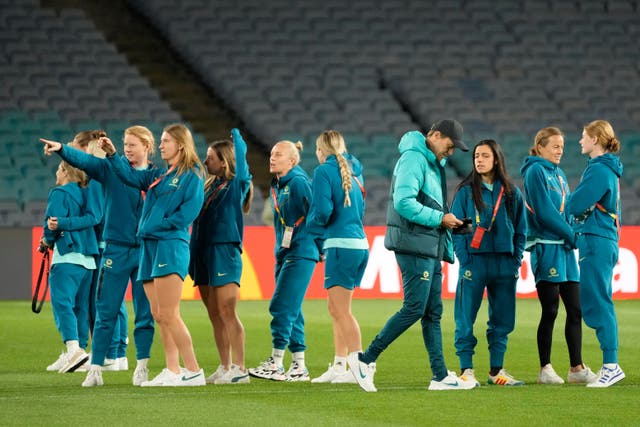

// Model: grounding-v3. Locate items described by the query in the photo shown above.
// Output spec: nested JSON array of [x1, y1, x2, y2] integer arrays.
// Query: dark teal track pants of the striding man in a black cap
[[361, 253, 447, 381]]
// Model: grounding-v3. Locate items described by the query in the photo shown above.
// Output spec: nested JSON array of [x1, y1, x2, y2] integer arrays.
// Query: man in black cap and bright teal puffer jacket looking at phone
[[351, 120, 475, 390]]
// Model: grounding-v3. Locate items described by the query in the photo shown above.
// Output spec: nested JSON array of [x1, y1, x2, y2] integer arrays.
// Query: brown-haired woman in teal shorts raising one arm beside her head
[[189, 129, 253, 384]]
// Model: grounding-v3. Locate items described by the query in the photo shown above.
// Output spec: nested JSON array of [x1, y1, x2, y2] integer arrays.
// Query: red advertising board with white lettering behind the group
[[32, 226, 640, 300]]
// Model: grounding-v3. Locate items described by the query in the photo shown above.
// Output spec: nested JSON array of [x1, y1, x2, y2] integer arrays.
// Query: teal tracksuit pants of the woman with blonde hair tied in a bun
[[269, 257, 316, 353]]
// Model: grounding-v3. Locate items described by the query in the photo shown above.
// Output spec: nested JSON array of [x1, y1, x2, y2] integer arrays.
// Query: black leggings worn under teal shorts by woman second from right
[[536, 281, 582, 366]]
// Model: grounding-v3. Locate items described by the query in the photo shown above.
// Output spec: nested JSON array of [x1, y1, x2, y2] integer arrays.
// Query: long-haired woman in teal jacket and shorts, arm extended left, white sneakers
[[101, 124, 206, 387]]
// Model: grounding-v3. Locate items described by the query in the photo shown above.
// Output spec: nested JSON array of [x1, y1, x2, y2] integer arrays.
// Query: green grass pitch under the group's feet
[[0, 299, 640, 427]]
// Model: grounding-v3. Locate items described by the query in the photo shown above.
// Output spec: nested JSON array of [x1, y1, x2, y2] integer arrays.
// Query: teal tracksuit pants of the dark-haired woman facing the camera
[[454, 254, 518, 369]]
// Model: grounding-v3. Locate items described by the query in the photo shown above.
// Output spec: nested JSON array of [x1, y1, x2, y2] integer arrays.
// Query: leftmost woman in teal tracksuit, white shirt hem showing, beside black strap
[[41, 162, 98, 372]]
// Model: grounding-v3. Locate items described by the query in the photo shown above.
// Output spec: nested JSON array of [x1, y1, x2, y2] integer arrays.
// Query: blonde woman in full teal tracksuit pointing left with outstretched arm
[[42, 126, 154, 387]]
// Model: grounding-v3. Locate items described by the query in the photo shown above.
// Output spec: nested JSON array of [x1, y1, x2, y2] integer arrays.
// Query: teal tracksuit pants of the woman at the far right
[[577, 234, 618, 363]]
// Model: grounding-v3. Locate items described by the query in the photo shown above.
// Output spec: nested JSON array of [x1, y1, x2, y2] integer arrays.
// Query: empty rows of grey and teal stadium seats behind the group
[[0, 0, 640, 225]]
